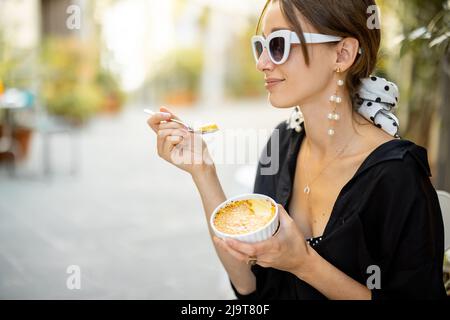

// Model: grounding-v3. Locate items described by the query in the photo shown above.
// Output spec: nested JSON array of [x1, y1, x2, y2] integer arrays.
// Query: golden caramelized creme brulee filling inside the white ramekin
[[214, 199, 276, 234]]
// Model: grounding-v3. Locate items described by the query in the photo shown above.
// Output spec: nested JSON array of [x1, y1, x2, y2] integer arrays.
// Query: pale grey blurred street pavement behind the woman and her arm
[[0, 100, 286, 299]]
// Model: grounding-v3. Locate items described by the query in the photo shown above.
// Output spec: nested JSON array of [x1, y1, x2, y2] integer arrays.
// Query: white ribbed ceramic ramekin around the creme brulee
[[209, 193, 279, 243]]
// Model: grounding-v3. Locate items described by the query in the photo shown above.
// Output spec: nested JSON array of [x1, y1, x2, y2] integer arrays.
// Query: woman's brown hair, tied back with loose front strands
[[256, 0, 381, 109]]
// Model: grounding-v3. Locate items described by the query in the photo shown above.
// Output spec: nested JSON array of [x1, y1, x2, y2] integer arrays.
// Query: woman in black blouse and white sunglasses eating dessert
[[148, 0, 445, 299]]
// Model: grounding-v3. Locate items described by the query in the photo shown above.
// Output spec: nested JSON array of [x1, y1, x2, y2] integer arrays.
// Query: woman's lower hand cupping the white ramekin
[[214, 204, 309, 273]]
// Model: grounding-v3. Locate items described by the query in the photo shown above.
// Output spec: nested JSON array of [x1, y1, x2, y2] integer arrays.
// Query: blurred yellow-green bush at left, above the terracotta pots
[[41, 38, 123, 124]]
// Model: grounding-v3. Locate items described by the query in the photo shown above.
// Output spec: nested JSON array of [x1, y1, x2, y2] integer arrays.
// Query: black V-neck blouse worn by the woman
[[230, 122, 445, 299]]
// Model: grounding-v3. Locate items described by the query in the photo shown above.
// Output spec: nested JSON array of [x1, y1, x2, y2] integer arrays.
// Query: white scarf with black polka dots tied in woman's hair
[[287, 76, 400, 138]]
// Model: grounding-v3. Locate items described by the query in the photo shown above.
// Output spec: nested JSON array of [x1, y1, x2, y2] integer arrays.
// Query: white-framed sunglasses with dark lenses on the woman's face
[[252, 30, 343, 64]]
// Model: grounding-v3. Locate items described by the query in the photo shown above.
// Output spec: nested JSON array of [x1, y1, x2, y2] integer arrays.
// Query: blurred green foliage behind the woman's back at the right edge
[[389, 0, 450, 146]]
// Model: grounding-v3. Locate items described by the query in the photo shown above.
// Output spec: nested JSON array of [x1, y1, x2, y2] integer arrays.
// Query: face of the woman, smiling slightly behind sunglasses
[[257, 1, 336, 108]]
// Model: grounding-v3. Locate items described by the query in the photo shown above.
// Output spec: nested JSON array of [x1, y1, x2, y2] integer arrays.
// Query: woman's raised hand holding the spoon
[[147, 107, 214, 176]]
